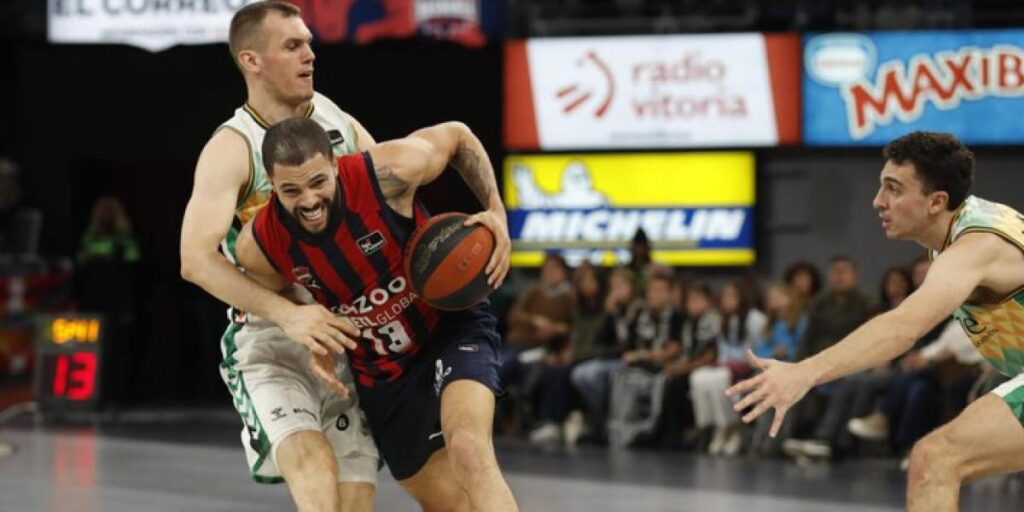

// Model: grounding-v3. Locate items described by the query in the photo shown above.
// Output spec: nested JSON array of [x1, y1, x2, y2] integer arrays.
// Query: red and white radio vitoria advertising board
[[505, 34, 800, 150]]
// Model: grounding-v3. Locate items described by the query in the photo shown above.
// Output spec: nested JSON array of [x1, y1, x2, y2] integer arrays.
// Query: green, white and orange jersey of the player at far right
[[932, 196, 1024, 377]]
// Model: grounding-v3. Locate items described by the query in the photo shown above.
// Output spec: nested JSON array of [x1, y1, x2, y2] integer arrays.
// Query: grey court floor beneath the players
[[0, 410, 1024, 512]]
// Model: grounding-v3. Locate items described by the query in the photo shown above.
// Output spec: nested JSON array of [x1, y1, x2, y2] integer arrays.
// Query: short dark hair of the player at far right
[[882, 131, 974, 210]]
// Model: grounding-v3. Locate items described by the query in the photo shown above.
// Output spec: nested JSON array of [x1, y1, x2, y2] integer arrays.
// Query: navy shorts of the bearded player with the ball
[[356, 304, 503, 480]]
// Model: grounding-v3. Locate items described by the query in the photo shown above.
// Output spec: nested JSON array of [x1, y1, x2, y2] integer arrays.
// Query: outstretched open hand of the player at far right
[[725, 349, 814, 437]]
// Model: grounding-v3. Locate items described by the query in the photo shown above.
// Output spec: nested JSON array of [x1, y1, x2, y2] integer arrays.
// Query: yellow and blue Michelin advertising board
[[504, 152, 755, 266]]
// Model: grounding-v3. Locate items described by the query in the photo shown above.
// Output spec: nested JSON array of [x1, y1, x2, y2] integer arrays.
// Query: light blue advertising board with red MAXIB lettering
[[804, 29, 1024, 145]]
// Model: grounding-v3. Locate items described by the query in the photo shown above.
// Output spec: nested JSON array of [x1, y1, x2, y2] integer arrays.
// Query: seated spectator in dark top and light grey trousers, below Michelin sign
[[608, 274, 682, 446]]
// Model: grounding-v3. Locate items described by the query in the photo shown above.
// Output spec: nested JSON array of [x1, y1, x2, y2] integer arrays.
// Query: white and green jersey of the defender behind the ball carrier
[[217, 92, 358, 262]]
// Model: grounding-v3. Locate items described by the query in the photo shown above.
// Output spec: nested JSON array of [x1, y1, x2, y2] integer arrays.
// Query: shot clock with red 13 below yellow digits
[[34, 313, 105, 413]]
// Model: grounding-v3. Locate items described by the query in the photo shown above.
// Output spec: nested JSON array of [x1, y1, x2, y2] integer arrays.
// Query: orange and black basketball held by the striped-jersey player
[[403, 213, 495, 311]]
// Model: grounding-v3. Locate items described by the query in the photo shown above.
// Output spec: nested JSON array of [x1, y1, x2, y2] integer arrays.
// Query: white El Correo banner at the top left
[[48, 0, 256, 51]]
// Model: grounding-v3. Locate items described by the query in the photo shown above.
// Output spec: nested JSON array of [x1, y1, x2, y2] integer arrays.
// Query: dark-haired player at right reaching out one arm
[[728, 132, 1024, 512]]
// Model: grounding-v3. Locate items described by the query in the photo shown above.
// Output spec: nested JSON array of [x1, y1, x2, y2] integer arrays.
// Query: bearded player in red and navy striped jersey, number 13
[[237, 119, 516, 512]]
